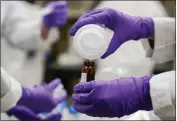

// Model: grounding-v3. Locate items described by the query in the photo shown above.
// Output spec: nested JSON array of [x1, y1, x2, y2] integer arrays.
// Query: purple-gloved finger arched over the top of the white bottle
[[70, 12, 105, 36]]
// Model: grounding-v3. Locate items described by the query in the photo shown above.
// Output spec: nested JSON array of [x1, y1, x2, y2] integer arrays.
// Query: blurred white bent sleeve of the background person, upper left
[[2, 1, 58, 50]]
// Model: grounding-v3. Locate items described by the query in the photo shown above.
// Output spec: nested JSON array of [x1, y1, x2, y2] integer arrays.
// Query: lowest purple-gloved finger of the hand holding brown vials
[[73, 102, 93, 113]]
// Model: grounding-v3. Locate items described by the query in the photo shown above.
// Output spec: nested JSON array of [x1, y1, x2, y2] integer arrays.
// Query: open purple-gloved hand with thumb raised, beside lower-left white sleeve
[[14, 79, 67, 113]]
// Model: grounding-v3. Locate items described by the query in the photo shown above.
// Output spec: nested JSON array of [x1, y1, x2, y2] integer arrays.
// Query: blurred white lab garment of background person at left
[[1, 1, 58, 86]]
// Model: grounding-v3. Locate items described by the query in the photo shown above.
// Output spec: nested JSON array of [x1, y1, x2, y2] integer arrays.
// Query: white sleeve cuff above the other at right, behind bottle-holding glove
[[152, 17, 176, 64]]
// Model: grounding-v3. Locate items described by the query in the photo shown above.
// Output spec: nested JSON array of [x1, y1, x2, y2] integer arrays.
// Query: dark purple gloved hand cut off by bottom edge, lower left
[[7, 106, 62, 121]]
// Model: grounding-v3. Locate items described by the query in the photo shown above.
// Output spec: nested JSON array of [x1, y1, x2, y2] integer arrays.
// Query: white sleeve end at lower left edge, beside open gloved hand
[[1, 67, 22, 112]]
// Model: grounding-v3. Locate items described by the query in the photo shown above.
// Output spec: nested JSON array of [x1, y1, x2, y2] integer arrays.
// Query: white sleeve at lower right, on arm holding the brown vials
[[150, 71, 176, 120]]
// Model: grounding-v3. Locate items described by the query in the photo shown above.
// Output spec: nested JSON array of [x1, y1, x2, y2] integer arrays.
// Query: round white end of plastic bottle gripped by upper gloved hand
[[74, 24, 110, 60]]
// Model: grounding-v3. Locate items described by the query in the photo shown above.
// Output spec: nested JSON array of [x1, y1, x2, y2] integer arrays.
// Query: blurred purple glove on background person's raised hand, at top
[[43, 1, 68, 28]]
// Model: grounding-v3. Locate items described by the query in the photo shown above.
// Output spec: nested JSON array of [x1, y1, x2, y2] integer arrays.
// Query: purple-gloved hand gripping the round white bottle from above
[[70, 8, 154, 59]]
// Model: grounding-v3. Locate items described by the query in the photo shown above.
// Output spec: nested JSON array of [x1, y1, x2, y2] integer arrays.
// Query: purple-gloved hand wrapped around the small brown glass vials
[[72, 76, 152, 118]]
